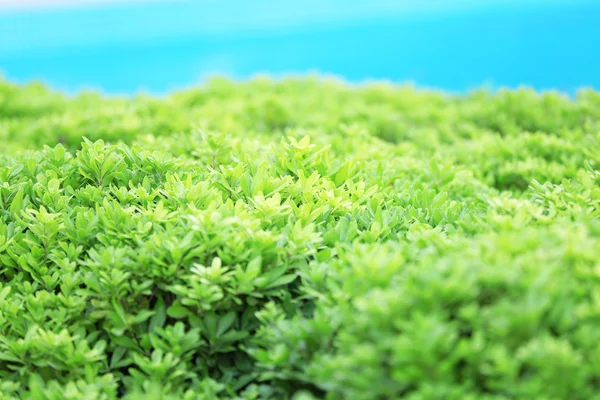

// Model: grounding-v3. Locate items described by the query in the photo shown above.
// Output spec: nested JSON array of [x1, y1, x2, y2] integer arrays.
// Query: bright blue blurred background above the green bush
[[0, 0, 600, 94]]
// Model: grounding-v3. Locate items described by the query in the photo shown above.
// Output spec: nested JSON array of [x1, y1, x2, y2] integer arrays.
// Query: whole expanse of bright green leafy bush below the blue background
[[0, 78, 600, 400]]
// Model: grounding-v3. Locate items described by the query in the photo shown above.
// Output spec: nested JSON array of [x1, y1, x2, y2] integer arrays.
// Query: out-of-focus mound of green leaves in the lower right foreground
[[253, 225, 598, 399]]
